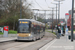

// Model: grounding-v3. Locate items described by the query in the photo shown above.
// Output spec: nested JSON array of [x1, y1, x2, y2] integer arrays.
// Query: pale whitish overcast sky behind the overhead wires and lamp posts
[[28, 0, 75, 18]]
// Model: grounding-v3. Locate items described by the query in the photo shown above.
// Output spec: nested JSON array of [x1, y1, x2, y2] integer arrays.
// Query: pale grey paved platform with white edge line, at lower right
[[39, 36, 75, 50]]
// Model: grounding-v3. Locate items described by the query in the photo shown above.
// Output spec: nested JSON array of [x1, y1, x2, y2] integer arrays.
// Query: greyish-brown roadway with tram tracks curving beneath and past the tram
[[0, 32, 55, 50]]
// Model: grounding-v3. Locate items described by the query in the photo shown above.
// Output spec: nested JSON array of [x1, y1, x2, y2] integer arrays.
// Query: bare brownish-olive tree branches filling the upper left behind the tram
[[0, 0, 31, 29]]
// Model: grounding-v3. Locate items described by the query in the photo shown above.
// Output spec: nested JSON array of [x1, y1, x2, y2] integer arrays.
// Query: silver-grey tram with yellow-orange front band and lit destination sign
[[17, 19, 45, 41]]
